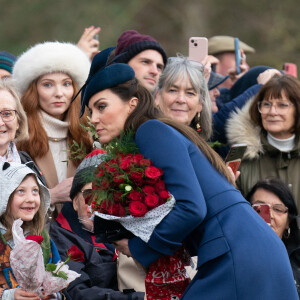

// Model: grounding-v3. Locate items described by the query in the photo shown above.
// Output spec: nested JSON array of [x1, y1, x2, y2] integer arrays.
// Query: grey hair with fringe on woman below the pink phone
[[157, 56, 212, 140]]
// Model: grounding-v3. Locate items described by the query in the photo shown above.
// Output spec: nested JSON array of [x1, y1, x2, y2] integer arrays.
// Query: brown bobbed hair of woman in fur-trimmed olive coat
[[250, 74, 300, 136]]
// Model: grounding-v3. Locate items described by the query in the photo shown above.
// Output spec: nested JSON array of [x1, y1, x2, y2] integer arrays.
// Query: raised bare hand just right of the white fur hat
[[77, 26, 101, 60]]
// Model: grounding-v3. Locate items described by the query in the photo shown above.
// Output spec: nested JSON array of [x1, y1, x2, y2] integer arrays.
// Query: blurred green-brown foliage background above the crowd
[[0, 0, 300, 69]]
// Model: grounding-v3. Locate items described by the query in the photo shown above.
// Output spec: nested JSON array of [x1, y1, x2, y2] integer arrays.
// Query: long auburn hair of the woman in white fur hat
[[17, 80, 92, 166]]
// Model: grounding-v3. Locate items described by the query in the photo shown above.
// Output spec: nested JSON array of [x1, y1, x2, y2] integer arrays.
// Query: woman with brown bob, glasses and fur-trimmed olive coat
[[227, 75, 300, 207]]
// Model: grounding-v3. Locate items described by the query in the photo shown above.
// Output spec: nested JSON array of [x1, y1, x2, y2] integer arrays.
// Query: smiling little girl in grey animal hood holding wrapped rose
[[0, 162, 59, 300]]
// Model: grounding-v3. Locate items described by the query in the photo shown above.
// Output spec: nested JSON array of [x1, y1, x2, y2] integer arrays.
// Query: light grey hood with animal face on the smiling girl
[[0, 162, 50, 216]]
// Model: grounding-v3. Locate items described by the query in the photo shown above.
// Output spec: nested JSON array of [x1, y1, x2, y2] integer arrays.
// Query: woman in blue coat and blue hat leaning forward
[[77, 52, 298, 300]]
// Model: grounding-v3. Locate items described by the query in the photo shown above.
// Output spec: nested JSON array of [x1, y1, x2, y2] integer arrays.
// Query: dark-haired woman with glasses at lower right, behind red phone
[[246, 178, 300, 296]]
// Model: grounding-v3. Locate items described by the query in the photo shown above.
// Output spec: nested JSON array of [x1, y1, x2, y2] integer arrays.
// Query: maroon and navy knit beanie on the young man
[[115, 30, 168, 65]]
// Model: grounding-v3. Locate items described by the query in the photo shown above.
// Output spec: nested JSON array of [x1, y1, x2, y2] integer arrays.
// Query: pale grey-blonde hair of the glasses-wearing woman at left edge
[[0, 78, 29, 142]]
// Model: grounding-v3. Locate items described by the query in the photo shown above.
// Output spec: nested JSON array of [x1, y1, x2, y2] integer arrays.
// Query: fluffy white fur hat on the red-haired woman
[[13, 42, 91, 95]]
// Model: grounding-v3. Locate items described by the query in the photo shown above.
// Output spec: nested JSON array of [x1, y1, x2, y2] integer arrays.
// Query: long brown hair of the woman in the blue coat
[[110, 79, 234, 184]]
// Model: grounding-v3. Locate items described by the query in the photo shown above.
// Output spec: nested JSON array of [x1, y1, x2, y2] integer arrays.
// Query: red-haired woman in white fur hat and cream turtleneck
[[13, 42, 92, 211]]
